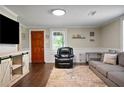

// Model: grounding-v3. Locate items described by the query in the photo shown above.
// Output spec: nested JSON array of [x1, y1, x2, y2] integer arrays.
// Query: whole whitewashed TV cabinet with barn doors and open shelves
[[0, 52, 29, 87]]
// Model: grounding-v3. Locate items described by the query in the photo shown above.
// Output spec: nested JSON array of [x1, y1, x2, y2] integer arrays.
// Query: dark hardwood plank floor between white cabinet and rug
[[12, 64, 54, 87]]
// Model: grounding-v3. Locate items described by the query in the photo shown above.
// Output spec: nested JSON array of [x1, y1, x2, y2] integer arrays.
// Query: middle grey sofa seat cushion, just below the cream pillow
[[96, 64, 124, 77]]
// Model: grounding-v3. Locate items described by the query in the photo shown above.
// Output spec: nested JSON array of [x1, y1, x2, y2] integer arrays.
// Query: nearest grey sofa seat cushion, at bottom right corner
[[108, 72, 124, 87]]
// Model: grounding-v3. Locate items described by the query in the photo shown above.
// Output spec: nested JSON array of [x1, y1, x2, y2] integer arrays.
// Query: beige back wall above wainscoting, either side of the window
[[45, 28, 100, 48]]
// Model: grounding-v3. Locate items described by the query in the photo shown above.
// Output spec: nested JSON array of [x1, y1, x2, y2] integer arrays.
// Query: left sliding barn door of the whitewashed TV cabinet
[[0, 58, 12, 87]]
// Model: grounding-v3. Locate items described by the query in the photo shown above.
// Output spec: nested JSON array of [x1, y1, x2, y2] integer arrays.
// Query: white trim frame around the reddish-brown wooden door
[[29, 29, 46, 63]]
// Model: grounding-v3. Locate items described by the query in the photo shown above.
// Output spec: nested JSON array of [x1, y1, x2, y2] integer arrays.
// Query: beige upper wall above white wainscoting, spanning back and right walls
[[30, 20, 121, 49]]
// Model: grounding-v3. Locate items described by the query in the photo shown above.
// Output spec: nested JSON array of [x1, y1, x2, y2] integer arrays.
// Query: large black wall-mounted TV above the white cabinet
[[0, 14, 19, 44]]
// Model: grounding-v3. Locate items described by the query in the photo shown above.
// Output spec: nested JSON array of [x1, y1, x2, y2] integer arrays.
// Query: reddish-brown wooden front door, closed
[[31, 31, 44, 63]]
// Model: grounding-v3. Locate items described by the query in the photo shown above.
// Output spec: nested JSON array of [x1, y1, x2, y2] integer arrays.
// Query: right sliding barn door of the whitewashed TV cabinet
[[23, 53, 29, 74]]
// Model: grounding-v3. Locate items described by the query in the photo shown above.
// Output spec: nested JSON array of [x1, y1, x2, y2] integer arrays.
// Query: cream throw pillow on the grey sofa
[[103, 54, 117, 65]]
